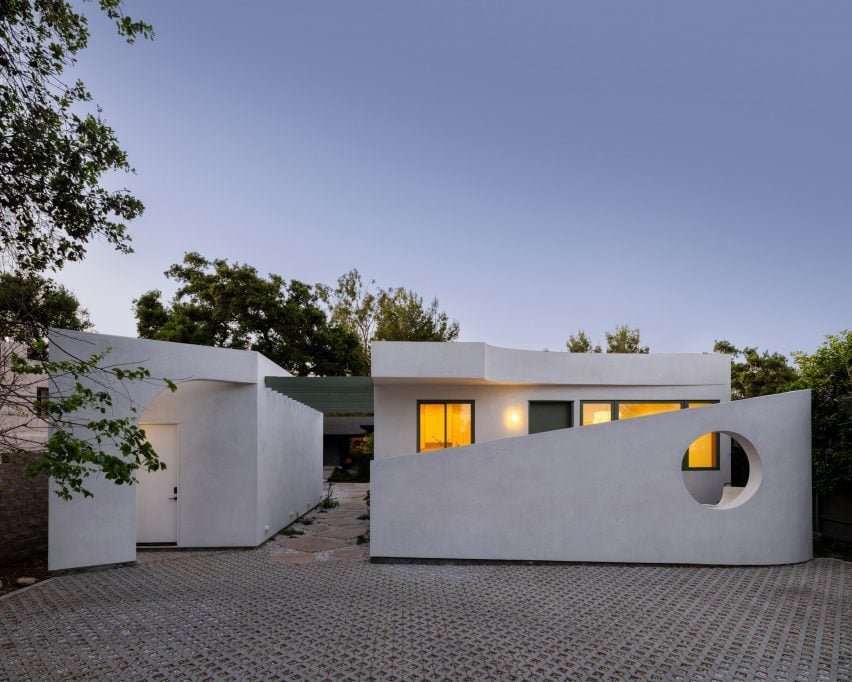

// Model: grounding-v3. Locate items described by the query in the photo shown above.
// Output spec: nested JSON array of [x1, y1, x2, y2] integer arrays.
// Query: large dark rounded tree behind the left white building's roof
[[134, 253, 367, 375]]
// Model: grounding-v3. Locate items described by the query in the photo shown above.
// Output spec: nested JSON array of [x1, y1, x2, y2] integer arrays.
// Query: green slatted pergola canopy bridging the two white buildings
[[265, 377, 373, 415]]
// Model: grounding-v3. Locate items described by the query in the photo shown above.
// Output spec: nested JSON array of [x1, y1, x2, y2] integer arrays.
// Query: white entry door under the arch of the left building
[[136, 424, 178, 544]]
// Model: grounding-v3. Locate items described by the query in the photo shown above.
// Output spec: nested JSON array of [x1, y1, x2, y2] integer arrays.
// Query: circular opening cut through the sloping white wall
[[680, 431, 762, 509]]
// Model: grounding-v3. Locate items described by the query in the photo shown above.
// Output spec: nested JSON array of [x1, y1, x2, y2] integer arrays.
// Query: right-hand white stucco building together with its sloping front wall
[[371, 342, 811, 564]]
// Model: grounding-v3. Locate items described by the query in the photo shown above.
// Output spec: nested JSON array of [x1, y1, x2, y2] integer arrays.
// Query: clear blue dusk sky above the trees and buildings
[[60, 0, 852, 353]]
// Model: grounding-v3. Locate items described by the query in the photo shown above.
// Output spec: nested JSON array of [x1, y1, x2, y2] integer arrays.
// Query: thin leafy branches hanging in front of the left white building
[[0, 341, 175, 499]]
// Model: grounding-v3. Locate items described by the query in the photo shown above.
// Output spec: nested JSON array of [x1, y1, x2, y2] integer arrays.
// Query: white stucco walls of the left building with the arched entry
[[48, 330, 322, 571]]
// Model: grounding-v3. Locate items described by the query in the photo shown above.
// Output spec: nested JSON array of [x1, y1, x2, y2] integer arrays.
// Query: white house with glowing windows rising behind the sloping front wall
[[372, 342, 731, 503]]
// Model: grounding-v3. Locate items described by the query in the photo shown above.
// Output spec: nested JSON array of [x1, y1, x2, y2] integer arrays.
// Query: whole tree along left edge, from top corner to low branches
[[0, 0, 172, 498]]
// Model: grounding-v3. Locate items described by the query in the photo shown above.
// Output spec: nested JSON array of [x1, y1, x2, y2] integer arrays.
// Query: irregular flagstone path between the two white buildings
[[268, 483, 370, 564]]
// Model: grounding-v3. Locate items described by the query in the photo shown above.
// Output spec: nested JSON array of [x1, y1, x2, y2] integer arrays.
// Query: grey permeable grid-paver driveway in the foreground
[[0, 488, 852, 680]]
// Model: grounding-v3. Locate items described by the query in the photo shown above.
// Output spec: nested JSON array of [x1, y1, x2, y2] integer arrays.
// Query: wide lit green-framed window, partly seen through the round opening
[[580, 400, 719, 471]]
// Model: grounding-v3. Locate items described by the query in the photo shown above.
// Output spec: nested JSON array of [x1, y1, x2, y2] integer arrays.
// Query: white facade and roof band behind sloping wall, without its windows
[[372, 342, 731, 503]]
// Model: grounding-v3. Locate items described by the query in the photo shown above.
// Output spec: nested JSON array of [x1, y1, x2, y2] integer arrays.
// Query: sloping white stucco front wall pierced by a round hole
[[370, 391, 811, 565]]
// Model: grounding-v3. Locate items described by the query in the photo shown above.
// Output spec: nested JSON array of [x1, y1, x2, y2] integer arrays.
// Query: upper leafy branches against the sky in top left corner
[[0, 0, 153, 273]]
